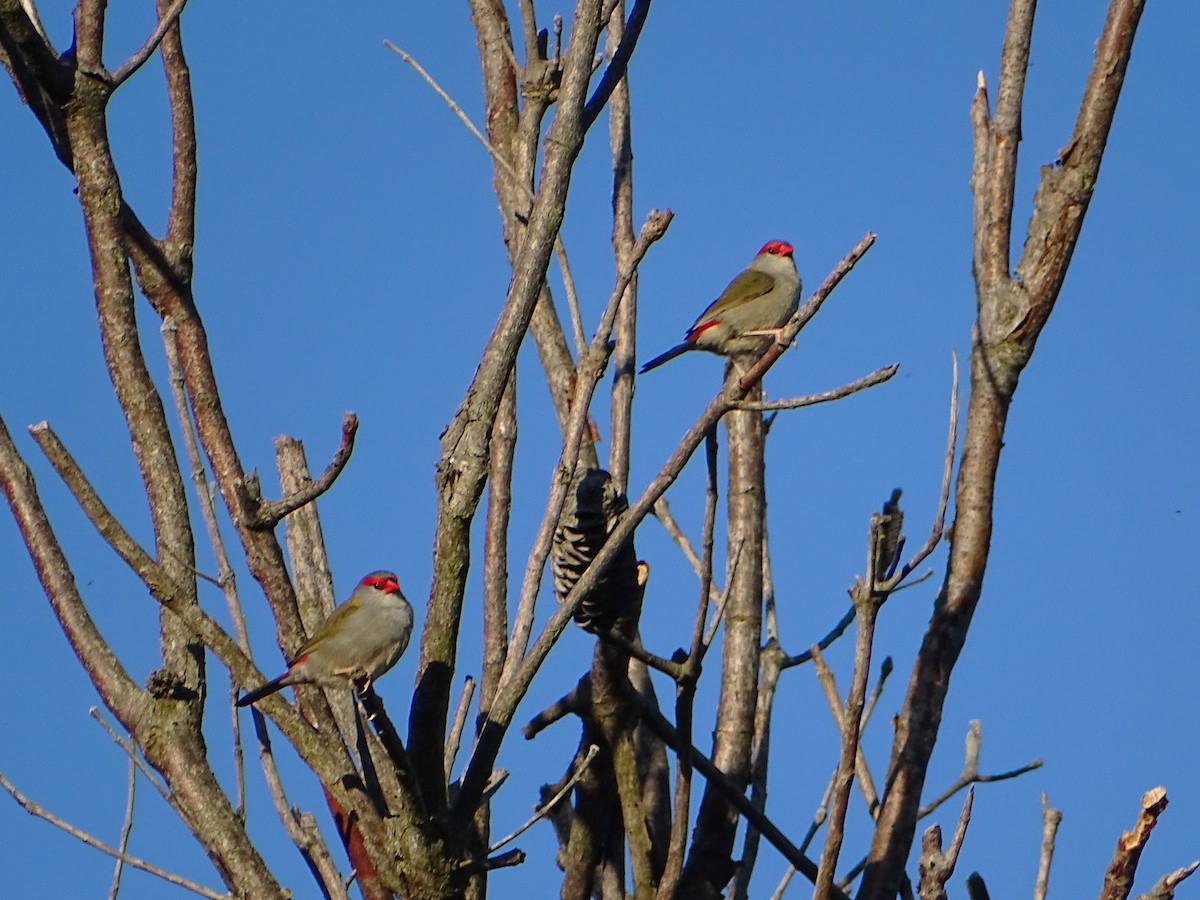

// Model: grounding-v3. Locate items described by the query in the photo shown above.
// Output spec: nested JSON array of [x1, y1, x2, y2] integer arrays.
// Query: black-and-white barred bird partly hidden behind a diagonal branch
[[551, 469, 642, 637]]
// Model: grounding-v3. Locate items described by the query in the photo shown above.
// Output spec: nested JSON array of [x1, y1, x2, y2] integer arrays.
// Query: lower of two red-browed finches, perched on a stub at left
[[238, 570, 413, 707]]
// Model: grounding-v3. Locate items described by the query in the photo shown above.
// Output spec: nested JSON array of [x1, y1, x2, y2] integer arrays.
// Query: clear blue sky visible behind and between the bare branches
[[0, 0, 1200, 900]]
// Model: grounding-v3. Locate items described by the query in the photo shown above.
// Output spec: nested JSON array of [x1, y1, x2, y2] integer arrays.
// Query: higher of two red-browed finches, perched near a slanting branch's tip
[[642, 241, 800, 374]]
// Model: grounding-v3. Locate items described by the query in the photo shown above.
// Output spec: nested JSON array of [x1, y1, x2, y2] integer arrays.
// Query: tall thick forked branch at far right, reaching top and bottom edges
[[859, 0, 1142, 900]]
